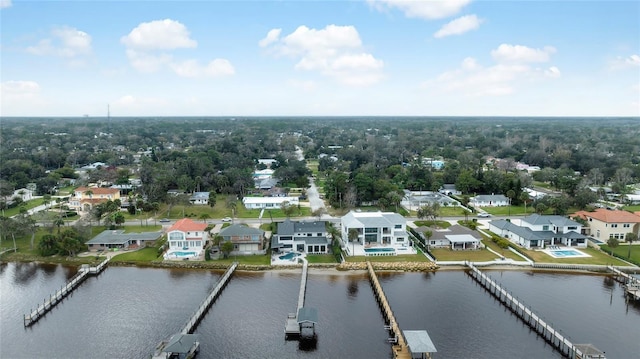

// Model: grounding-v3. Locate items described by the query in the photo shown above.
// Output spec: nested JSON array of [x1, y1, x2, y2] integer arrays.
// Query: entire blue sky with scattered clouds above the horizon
[[0, 0, 640, 116]]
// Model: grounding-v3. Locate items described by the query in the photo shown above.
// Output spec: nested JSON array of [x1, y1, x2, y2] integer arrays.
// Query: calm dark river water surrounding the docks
[[0, 263, 640, 359]]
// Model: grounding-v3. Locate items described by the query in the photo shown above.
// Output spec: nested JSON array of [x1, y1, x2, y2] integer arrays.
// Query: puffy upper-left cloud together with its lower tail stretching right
[[120, 19, 235, 78]]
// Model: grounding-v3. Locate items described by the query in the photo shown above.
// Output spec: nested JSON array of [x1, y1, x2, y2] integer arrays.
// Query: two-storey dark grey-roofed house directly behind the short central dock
[[271, 218, 331, 254]]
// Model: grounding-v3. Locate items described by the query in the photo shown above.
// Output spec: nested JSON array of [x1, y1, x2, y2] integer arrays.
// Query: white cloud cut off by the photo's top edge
[[368, 0, 471, 20]]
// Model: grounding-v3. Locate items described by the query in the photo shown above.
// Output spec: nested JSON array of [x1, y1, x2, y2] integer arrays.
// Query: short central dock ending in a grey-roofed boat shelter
[[284, 260, 318, 339]]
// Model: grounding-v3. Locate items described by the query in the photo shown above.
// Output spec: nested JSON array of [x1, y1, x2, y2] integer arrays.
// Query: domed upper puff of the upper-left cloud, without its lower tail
[[120, 19, 198, 50]]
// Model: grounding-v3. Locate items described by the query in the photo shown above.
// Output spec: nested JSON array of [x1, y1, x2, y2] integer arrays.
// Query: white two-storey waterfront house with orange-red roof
[[166, 218, 209, 256]]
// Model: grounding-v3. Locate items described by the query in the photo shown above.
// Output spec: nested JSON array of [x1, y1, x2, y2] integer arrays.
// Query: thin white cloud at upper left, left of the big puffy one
[[27, 26, 91, 59]]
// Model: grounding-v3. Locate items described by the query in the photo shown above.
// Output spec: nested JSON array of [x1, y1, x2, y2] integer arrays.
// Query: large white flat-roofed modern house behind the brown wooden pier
[[340, 211, 415, 255]]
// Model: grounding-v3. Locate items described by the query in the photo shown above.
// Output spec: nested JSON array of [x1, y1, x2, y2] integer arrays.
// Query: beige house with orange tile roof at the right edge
[[571, 208, 640, 242]]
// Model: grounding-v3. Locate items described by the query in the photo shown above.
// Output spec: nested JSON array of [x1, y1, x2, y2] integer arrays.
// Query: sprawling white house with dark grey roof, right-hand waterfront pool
[[489, 214, 587, 249]]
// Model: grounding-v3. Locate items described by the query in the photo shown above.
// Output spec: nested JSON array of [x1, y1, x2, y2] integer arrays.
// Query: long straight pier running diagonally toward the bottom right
[[466, 262, 606, 359]]
